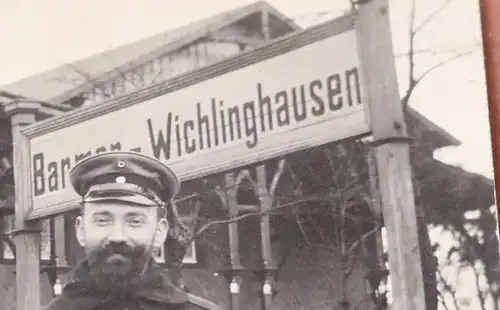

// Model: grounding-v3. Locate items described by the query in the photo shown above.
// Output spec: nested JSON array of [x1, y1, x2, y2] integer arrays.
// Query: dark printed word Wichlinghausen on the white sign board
[[147, 68, 361, 160]]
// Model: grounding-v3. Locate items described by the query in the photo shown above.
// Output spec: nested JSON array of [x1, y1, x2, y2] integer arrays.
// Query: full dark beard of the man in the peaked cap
[[87, 243, 151, 292]]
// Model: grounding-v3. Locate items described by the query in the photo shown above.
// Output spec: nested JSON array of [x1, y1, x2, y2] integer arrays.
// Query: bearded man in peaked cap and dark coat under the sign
[[42, 152, 221, 310]]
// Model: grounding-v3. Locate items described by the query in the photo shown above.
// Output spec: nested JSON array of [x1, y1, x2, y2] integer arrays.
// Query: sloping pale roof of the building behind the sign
[[0, 1, 460, 146]]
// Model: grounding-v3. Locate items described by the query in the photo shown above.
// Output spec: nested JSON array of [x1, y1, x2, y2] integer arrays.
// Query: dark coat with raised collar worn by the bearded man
[[42, 261, 223, 310]]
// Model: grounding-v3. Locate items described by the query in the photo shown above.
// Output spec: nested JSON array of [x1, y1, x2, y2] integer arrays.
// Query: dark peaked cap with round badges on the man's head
[[69, 151, 180, 206]]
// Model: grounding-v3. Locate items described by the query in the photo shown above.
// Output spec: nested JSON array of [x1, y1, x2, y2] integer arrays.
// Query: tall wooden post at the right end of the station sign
[[358, 0, 425, 310]]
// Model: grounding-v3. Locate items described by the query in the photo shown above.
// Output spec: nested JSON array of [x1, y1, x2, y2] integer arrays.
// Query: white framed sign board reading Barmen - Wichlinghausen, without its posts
[[17, 16, 370, 218]]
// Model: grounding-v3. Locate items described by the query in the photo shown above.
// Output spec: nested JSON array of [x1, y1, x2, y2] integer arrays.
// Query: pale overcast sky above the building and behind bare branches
[[0, 0, 493, 177]]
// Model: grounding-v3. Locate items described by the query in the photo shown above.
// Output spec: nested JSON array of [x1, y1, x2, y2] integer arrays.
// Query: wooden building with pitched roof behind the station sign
[[0, 2, 498, 310]]
